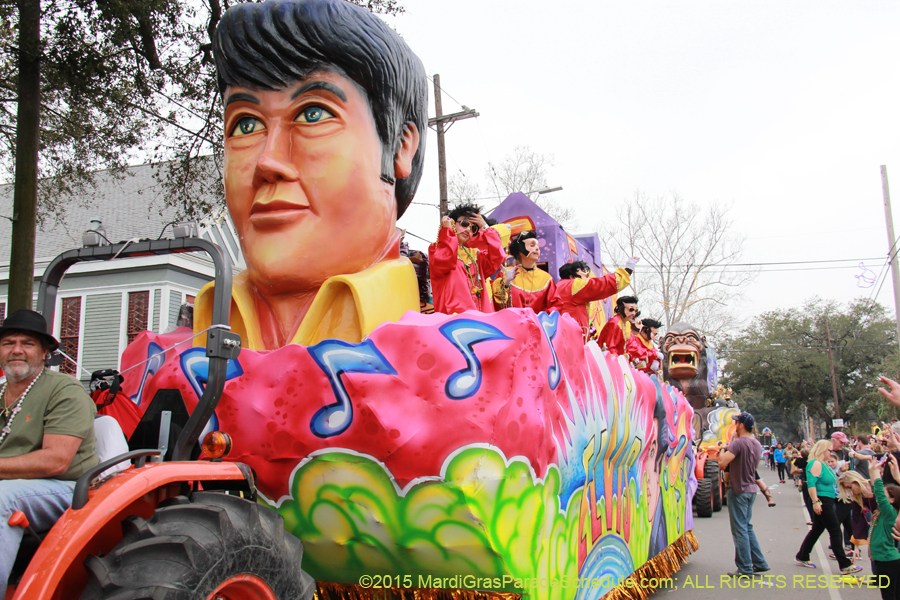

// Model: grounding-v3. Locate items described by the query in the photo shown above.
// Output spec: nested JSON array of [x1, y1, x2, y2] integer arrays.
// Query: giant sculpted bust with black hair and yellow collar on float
[[194, 0, 428, 350]]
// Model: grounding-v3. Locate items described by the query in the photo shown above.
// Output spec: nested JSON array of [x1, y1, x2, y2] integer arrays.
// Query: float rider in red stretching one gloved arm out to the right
[[552, 257, 638, 339]]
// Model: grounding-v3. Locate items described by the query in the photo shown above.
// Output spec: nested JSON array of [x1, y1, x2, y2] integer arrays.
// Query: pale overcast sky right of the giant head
[[385, 0, 900, 330]]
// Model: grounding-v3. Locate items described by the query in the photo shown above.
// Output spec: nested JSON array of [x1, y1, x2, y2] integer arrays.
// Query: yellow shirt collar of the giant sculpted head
[[194, 257, 419, 350]]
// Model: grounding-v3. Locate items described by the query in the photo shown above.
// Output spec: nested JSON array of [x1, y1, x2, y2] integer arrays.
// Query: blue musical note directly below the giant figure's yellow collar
[[309, 340, 397, 438]]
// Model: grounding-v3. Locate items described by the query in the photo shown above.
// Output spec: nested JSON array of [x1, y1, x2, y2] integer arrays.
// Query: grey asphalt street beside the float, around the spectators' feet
[[650, 465, 881, 600]]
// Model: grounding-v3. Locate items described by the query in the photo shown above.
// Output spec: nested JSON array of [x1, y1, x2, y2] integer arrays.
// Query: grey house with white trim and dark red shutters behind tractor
[[0, 165, 245, 381]]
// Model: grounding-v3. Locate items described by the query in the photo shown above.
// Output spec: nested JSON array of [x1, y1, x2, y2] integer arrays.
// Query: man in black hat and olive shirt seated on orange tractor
[[0, 309, 99, 583]]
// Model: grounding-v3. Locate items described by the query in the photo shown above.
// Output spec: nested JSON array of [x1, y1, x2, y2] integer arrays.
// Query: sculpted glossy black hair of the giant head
[[213, 0, 428, 218]]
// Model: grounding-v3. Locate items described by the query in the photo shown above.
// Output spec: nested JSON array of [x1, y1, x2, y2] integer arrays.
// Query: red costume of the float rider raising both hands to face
[[428, 227, 506, 315]]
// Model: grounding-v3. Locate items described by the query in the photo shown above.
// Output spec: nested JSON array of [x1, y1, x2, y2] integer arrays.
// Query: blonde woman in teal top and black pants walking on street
[[796, 440, 862, 575]]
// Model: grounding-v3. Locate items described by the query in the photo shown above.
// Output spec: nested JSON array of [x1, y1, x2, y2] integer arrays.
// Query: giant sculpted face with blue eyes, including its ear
[[225, 71, 418, 295]]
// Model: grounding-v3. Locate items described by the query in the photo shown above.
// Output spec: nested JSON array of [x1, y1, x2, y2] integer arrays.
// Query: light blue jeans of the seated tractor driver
[[0, 479, 75, 586]]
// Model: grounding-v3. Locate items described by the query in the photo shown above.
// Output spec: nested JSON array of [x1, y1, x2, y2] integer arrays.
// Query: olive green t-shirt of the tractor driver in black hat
[[0, 369, 100, 481]]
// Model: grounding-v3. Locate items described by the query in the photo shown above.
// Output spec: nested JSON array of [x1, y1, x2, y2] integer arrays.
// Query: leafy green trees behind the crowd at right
[[719, 299, 898, 435]]
